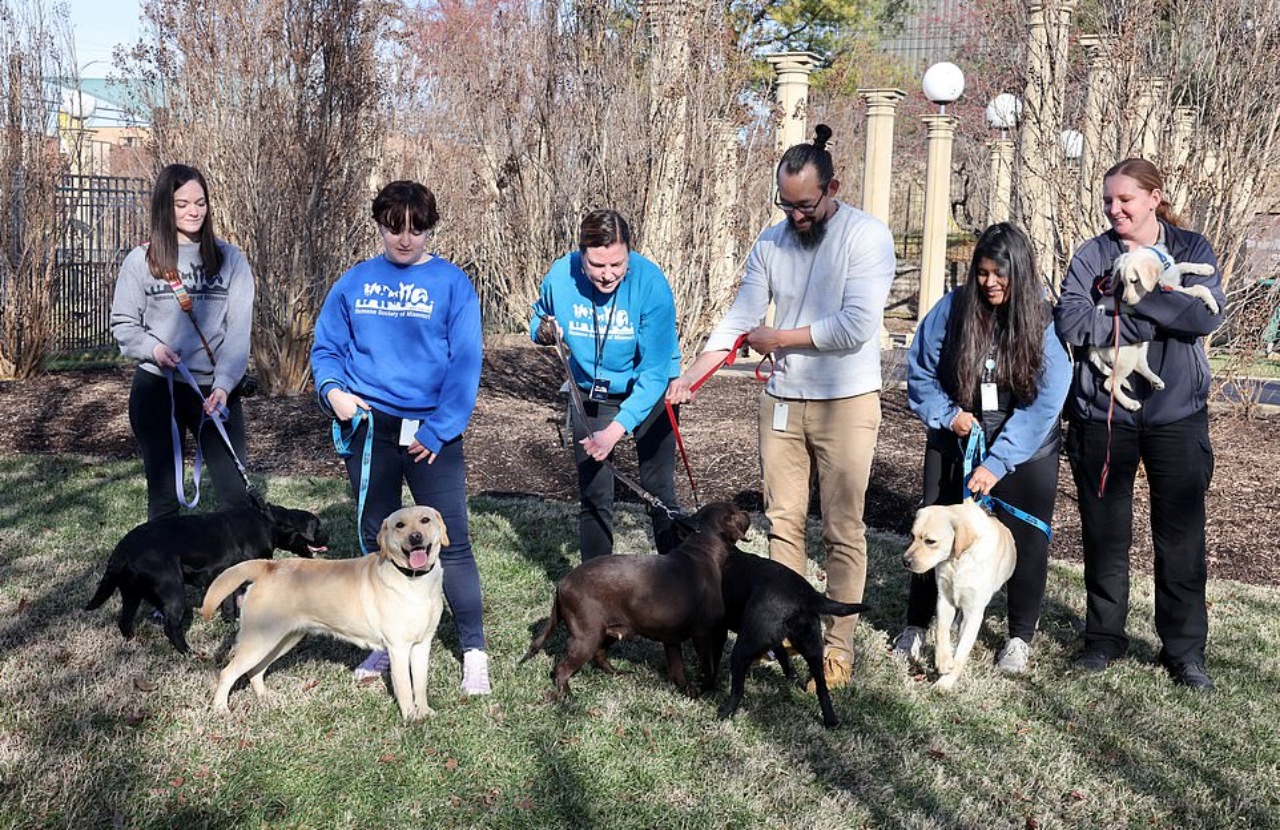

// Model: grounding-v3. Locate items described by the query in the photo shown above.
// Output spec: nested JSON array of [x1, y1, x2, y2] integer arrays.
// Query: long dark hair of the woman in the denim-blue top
[[938, 222, 1048, 412]]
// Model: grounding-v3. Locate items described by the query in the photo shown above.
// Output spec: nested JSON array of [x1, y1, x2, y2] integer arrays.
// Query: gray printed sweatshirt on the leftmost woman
[[111, 241, 253, 392]]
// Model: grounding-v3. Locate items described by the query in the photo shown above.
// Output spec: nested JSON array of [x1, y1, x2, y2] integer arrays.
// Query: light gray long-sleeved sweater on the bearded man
[[707, 202, 896, 401]]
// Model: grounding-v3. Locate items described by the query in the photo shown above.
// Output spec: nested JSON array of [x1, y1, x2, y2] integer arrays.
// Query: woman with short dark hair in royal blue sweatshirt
[[311, 182, 489, 694]]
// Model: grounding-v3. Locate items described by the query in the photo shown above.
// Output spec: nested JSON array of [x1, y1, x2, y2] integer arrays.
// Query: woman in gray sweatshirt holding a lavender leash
[[111, 164, 253, 519]]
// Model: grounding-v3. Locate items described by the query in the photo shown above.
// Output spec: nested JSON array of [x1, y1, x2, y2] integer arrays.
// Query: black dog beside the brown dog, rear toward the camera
[[719, 548, 868, 729]]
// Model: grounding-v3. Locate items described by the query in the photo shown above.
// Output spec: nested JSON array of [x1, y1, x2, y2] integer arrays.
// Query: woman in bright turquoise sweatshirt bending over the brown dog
[[529, 210, 680, 562]]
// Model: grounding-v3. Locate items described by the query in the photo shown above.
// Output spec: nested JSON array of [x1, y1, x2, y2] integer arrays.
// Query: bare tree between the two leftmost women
[[123, 0, 398, 393]]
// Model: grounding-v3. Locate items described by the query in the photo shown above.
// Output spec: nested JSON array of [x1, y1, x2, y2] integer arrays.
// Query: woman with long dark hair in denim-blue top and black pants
[[893, 223, 1071, 674]]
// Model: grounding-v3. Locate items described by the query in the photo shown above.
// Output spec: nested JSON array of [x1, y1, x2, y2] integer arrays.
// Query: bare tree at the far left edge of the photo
[[0, 0, 74, 379]]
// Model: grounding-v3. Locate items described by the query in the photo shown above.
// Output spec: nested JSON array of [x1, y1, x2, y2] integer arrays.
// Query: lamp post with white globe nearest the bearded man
[[916, 61, 964, 320]]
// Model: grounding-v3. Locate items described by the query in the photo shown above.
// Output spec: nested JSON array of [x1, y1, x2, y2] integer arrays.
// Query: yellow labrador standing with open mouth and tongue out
[[201, 506, 449, 720]]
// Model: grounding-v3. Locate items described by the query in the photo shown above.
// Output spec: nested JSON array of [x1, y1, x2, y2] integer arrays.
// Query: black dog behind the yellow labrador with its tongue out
[[84, 496, 329, 655]]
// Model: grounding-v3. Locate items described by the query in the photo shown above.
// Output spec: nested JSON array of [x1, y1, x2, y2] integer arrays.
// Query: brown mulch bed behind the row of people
[[0, 336, 1280, 585]]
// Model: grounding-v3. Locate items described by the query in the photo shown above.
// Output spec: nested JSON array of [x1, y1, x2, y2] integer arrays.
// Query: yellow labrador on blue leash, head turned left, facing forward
[[902, 501, 1018, 692]]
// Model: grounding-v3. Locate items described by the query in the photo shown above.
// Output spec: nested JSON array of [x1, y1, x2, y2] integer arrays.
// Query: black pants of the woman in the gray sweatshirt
[[129, 369, 248, 519]]
